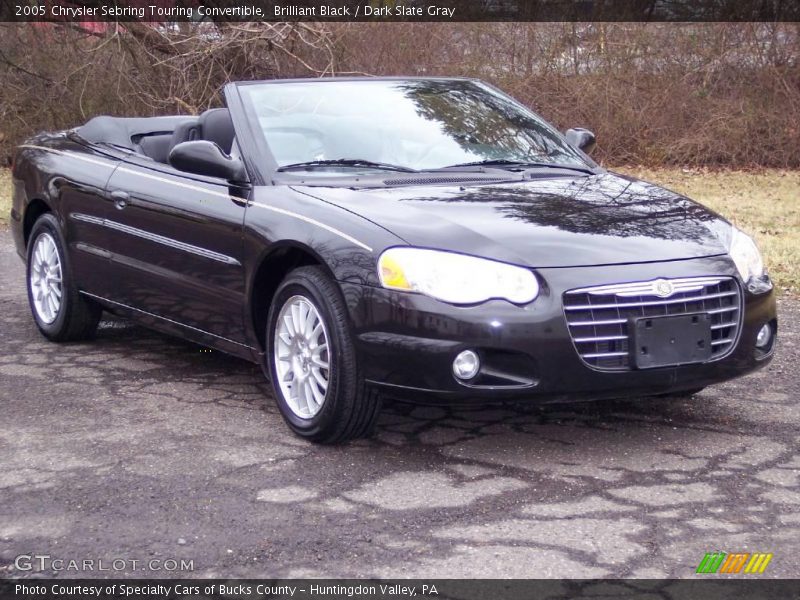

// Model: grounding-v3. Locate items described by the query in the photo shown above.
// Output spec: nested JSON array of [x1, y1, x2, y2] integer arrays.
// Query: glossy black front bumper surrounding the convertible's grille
[[342, 256, 777, 403]]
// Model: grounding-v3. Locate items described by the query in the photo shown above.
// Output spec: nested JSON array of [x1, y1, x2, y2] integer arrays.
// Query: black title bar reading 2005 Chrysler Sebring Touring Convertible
[[0, 0, 800, 22]]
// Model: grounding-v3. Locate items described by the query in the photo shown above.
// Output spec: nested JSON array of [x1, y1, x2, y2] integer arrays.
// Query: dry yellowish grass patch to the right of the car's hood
[[614, 167, 800, 294]]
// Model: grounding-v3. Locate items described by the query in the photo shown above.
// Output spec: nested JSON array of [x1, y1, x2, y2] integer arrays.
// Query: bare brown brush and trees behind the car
[[0, 23, 800, 168]]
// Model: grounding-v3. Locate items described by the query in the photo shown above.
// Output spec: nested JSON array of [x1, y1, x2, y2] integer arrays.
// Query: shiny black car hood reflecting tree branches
[[298, 173, 730, 268]]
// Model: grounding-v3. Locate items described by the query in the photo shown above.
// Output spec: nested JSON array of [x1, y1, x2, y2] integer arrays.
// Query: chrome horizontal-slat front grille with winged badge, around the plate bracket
[[564, 277, 742, 371]]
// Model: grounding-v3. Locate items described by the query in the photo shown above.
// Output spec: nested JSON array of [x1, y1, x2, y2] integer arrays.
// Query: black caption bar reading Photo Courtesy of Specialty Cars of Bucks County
[[0, 576, 800, 600]]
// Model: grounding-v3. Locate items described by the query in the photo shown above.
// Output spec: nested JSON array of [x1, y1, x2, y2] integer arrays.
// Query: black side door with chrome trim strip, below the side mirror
[[107, 157, 245, 344]]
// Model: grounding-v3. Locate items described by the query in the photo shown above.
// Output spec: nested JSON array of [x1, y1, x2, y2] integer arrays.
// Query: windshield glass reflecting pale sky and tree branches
[[234, 79, 591, 176]]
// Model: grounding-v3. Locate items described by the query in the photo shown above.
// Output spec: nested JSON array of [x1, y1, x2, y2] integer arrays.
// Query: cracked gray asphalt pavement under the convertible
[[0, 230, 800, 578]]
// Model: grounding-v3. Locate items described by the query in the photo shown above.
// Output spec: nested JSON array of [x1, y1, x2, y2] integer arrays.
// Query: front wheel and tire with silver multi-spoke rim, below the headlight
[[264, 267, 380, 444]]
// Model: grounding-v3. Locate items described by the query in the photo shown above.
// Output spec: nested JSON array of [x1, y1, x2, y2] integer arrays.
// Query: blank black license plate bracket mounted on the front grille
[[631, 313, 712, 369]]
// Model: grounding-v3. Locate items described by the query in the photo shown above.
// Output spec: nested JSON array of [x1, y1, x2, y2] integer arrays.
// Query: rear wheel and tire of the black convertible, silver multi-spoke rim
[[25, 213, 103, 342]]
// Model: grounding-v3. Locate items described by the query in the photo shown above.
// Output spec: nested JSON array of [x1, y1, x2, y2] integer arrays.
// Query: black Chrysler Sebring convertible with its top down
[[12, 78, 777, 442]]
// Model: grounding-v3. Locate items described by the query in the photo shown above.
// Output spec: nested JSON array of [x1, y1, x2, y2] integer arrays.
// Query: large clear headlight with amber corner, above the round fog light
[[378, 247, 539, 304]]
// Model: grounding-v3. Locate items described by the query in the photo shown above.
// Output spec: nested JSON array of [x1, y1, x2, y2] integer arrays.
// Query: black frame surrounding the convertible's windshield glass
[[231, 77, 603, 185]]
